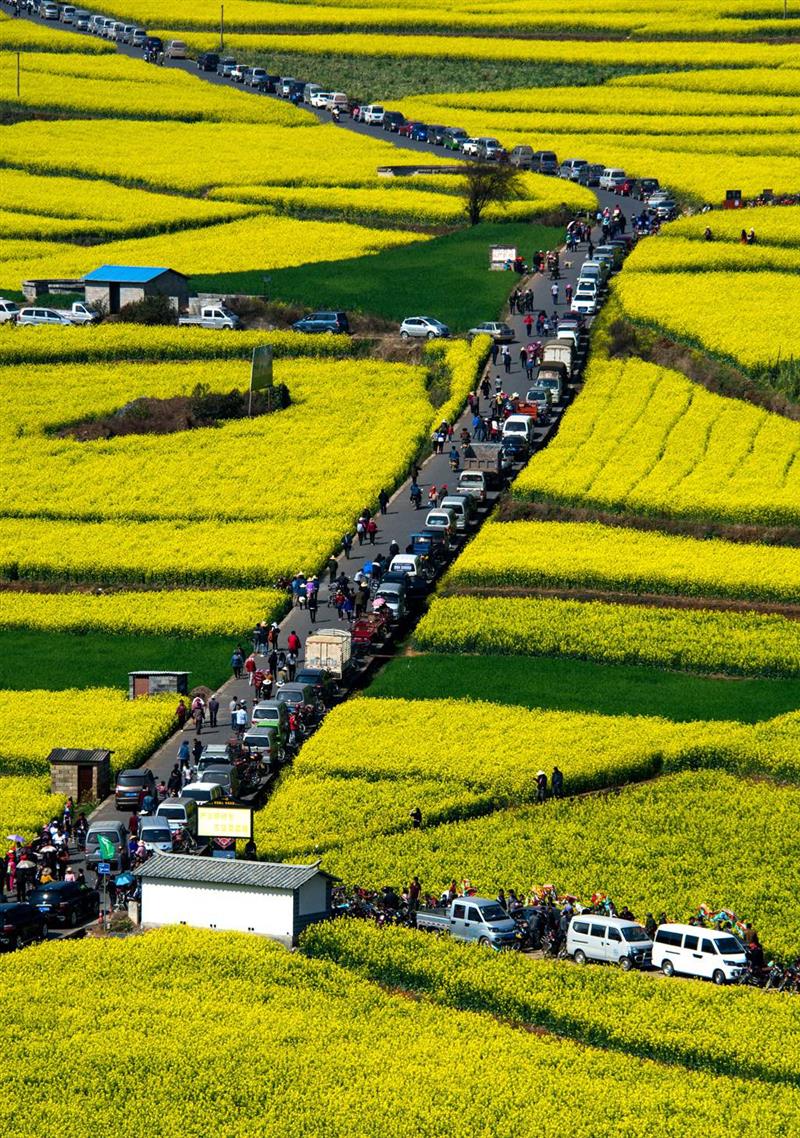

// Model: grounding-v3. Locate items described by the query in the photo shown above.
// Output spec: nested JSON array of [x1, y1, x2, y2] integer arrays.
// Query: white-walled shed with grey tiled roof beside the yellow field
[[134, 854, 333, 948]]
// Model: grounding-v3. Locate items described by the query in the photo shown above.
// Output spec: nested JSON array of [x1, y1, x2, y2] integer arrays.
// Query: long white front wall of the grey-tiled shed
[[141, 880, 294, 940]]
